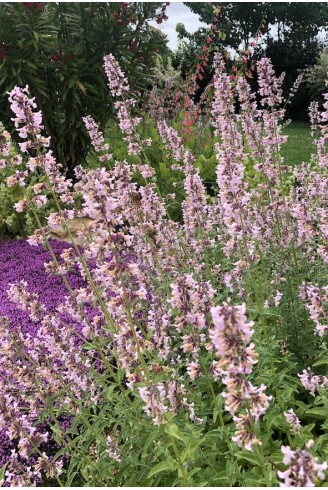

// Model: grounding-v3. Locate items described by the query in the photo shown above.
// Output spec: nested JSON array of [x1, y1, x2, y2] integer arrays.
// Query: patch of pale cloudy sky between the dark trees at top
[[151, 2, 206, 50]]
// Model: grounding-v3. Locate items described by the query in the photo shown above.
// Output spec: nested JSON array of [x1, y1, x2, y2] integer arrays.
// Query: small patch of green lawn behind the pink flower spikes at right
[[281, 121, 316, 165]]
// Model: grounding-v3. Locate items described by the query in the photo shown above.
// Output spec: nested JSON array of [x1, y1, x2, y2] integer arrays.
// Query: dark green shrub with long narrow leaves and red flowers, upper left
[[0, 2, 166, 176]]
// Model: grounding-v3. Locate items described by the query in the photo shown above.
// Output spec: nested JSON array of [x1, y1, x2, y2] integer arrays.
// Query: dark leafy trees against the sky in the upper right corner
[[177, 2, 328, 118]]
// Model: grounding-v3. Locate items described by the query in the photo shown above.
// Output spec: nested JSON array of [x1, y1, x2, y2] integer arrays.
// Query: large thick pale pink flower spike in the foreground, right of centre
[[210, 303, 272, 451]]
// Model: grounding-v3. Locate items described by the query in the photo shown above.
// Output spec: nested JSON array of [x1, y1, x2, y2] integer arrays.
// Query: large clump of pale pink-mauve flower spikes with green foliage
[[0, 55, 328, 486]]
